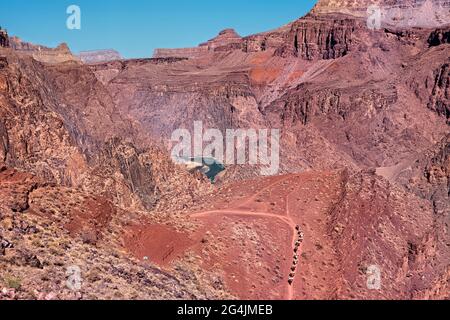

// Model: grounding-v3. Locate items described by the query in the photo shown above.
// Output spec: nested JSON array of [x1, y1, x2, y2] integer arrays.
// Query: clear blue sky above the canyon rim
[[0, 0, 316, 58]]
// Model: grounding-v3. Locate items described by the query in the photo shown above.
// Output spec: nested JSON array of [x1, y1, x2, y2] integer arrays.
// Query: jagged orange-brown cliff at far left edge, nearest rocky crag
[[0, 52, 86, 183]]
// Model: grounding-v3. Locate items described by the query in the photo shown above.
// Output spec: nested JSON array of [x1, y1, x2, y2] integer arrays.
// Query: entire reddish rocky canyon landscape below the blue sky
[[0, 0, 450, 300]]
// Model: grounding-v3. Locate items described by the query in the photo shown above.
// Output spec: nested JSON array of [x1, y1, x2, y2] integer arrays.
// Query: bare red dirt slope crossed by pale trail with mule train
[[124, 172, 340, 300]]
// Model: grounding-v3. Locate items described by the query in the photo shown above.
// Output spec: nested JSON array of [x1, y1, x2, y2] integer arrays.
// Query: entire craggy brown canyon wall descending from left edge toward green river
[[0, 48, 211, 209]]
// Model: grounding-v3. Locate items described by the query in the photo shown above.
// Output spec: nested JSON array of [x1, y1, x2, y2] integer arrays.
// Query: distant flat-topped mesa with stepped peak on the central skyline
[[153, 29, 244, 58]]
